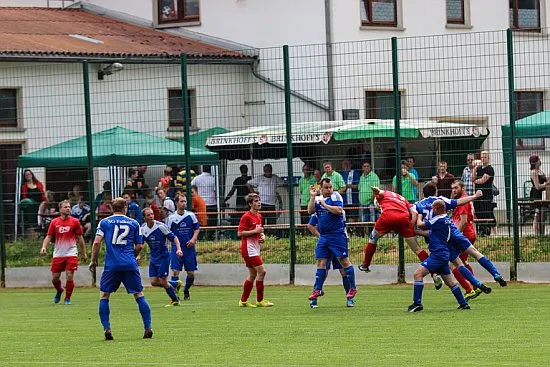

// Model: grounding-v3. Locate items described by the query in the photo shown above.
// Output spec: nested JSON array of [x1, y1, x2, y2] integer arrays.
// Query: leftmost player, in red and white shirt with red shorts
[[40, 200, 88, 305]]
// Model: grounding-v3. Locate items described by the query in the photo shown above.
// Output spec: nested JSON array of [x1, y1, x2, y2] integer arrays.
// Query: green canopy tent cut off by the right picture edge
[[501, 110, 550, 220]]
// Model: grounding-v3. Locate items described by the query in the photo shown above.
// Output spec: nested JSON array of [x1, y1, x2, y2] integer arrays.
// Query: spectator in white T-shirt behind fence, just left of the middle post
[[248, 163, 284, 237]]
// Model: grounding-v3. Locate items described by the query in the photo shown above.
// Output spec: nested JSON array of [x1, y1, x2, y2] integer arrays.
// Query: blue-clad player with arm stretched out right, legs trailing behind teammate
[[413, 182, 506, 293]]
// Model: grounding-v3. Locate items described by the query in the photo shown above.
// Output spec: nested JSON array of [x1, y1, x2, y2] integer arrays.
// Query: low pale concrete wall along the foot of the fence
[[6, 262, 540, 288]]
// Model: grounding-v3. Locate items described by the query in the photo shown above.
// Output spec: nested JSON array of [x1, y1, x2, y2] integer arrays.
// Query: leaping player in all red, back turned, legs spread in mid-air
[[359, 187, 443, 289]]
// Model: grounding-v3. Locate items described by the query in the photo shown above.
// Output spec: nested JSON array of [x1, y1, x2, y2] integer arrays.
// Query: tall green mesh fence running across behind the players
[[0, 31, 550, 282]]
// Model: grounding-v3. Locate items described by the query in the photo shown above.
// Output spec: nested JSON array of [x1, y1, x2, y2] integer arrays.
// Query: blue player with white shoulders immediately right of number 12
[[138, 208, 183, 307]]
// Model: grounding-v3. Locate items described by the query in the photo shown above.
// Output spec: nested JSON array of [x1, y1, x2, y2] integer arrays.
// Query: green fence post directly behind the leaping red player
[[391, 37, 405, 283]]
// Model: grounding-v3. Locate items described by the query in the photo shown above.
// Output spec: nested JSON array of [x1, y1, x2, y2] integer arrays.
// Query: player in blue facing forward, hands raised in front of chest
[[307, 178, 357, 301]]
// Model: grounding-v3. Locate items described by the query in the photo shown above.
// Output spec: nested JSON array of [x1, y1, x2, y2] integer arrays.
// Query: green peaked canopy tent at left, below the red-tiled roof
[[15, 126, 219, 233]]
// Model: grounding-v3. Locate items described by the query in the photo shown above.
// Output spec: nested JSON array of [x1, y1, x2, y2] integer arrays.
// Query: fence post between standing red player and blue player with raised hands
[[283, 45, 296, 284]]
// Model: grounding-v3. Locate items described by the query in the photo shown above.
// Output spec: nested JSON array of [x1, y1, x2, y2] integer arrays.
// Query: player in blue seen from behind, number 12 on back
[[89, 198, 153, 340]]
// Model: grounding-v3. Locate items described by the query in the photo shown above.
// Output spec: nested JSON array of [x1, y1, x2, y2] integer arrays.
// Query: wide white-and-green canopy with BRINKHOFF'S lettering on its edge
[[206, 119, 489, 170]]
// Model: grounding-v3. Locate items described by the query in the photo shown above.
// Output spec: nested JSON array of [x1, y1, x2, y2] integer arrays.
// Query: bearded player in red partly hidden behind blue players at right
[[451, 180, 482, 301]]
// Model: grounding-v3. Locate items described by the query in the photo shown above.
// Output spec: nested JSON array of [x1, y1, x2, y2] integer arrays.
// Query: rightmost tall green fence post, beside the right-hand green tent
[[506, 28, 521, 280]]
